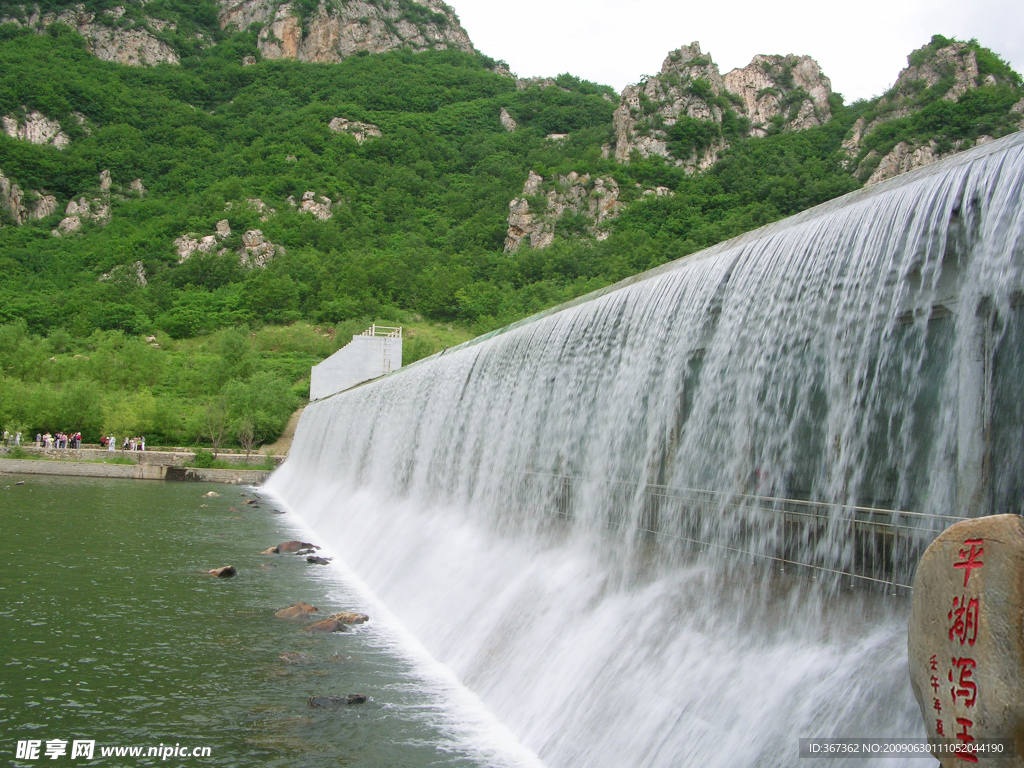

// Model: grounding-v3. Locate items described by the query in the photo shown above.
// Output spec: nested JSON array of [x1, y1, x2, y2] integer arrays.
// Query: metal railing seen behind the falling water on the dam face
[[526, 472, 968, 589]]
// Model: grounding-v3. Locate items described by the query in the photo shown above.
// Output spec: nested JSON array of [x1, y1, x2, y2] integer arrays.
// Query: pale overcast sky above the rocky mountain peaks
[[447, 0, 1024, 102]]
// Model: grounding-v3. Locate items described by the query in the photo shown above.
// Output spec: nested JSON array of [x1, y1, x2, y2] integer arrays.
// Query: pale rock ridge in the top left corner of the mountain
[[0, 3, 178, 67]]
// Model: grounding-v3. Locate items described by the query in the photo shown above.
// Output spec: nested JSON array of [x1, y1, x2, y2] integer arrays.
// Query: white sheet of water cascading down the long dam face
[[269, 134, 1024, 768]]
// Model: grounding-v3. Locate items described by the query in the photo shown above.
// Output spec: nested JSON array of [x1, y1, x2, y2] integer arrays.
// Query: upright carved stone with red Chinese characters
[[908, 515, 1024, 768]]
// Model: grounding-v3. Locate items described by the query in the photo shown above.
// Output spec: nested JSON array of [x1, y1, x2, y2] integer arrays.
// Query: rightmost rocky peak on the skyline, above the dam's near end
[[843, 40, 1024, 185]]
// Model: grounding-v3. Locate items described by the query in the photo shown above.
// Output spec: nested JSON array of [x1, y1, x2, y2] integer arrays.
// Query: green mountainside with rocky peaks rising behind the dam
[[0, 6, 1024, 442]]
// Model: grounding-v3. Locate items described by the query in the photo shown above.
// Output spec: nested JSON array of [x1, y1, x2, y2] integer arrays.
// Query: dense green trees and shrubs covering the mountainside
[[0, 24, 1021, 443]]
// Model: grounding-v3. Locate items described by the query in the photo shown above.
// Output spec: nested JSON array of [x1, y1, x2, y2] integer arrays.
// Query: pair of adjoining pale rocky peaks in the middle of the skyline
[[609, 42, 831, 172]]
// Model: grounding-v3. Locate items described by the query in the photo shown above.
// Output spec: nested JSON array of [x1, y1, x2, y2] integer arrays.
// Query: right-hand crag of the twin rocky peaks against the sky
[[723, 54, 831, 136]]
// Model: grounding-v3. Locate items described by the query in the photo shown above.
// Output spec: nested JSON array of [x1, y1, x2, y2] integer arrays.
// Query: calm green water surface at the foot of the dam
[[0, 475, 495, 768]]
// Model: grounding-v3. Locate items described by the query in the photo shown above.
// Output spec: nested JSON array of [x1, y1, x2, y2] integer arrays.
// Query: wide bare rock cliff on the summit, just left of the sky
[[220, 0, 473, 61]]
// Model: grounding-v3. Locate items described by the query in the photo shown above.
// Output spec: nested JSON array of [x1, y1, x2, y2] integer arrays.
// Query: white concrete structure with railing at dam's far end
[[309, 326, 401, 400]]
